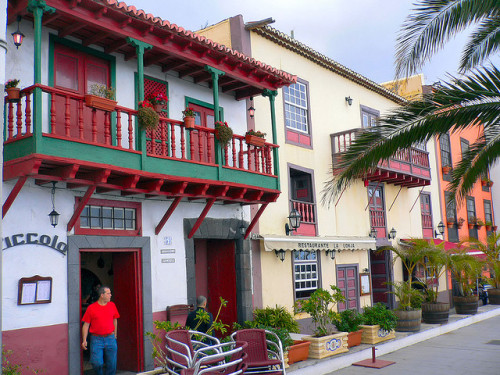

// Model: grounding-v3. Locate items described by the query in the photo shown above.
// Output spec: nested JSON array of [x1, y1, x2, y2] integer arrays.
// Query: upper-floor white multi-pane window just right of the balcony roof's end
[[283, 82, 309, 134]]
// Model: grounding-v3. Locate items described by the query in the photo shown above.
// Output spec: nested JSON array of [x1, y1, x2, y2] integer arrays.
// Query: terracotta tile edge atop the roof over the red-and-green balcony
[[101, 0, 297, 85]]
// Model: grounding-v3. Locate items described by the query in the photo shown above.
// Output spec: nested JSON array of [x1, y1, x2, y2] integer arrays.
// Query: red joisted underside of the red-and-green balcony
[[3, 154, 280, 204]]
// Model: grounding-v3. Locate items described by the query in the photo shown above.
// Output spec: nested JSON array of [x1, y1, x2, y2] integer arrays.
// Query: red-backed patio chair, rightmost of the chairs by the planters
[[231, 329, 286, 375]]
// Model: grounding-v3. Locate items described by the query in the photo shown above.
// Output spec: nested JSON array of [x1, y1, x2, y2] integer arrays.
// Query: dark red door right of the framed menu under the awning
[[370, 250, 392, 307]]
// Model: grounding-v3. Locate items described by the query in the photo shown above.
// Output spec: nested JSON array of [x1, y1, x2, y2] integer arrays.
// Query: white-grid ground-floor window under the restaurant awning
[[293, 250, 318, 299]]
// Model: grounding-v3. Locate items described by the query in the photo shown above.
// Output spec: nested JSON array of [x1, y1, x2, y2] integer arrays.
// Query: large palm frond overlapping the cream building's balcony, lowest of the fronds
[[321, 67, 500, 204]]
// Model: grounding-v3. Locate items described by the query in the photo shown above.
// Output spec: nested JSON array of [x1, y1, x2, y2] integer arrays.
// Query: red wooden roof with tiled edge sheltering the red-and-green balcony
[[7, 0, 297, 100]]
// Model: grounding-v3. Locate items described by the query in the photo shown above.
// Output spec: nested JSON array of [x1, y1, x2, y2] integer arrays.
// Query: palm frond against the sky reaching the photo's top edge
[[396, 0, 500, 77]]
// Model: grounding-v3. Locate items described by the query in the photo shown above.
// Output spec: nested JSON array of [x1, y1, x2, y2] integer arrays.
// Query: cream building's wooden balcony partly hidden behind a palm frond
[[330, 129, 431, 188]]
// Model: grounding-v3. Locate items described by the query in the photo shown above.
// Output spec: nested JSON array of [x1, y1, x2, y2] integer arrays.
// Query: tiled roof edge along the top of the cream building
[[251, 26, 406, 104]]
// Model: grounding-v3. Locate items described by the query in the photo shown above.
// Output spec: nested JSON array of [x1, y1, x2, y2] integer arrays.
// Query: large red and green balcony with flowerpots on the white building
[[4, 85, 279, 207]]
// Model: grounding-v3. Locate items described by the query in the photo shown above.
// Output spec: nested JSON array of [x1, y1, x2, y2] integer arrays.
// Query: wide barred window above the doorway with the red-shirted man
[[80, 205, 137, 230]]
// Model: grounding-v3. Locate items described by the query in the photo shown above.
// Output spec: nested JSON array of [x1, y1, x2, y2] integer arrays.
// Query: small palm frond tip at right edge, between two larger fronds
[[460, 14, 500, 72]]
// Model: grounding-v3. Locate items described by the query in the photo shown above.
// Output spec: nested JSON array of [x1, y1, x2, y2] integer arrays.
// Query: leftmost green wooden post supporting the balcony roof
[[28, 0, 56, 153]]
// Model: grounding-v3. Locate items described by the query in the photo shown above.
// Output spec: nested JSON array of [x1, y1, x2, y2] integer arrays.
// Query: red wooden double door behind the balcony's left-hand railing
[[54, 44, 110, 144]]
